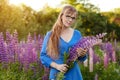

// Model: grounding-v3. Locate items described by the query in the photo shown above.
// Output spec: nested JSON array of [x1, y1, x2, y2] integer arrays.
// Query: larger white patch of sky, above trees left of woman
[[9, 0, 61, 11]]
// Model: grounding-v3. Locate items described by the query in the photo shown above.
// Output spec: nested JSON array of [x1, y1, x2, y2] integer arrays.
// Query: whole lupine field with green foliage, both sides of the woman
[[0, 31, 120, 80]]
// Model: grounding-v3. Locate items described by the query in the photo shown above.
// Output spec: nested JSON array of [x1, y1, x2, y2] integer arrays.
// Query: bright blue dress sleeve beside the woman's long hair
[[40, 32, 53, 67]]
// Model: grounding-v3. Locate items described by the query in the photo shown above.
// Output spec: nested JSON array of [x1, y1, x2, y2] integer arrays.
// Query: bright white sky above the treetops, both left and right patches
[[9, 0, 120, 11]]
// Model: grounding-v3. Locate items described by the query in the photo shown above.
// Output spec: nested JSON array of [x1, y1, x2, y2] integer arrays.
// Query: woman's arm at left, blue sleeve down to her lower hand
[[40, 32, 68, 72]]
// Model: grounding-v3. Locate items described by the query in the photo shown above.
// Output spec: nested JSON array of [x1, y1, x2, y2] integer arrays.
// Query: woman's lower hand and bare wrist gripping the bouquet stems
[[51, 62, 69, 73]]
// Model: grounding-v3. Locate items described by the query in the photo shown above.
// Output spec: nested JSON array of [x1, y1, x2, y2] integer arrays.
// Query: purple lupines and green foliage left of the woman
[[0, 31, 44, 80]]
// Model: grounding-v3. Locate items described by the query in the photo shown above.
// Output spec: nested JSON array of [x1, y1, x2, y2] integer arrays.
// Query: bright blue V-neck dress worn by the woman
[[40, 30, 87, 80]]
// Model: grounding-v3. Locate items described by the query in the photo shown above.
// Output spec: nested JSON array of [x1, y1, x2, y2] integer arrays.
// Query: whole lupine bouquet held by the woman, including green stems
[[56, 33, 107, 80]]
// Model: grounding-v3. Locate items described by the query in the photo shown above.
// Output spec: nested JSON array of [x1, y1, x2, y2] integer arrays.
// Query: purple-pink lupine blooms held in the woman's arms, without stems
[[68, 33, 106, 62]]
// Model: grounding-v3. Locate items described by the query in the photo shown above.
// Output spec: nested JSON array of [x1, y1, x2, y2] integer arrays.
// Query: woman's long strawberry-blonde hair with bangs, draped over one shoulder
[[47, 5, 77, 59]]
